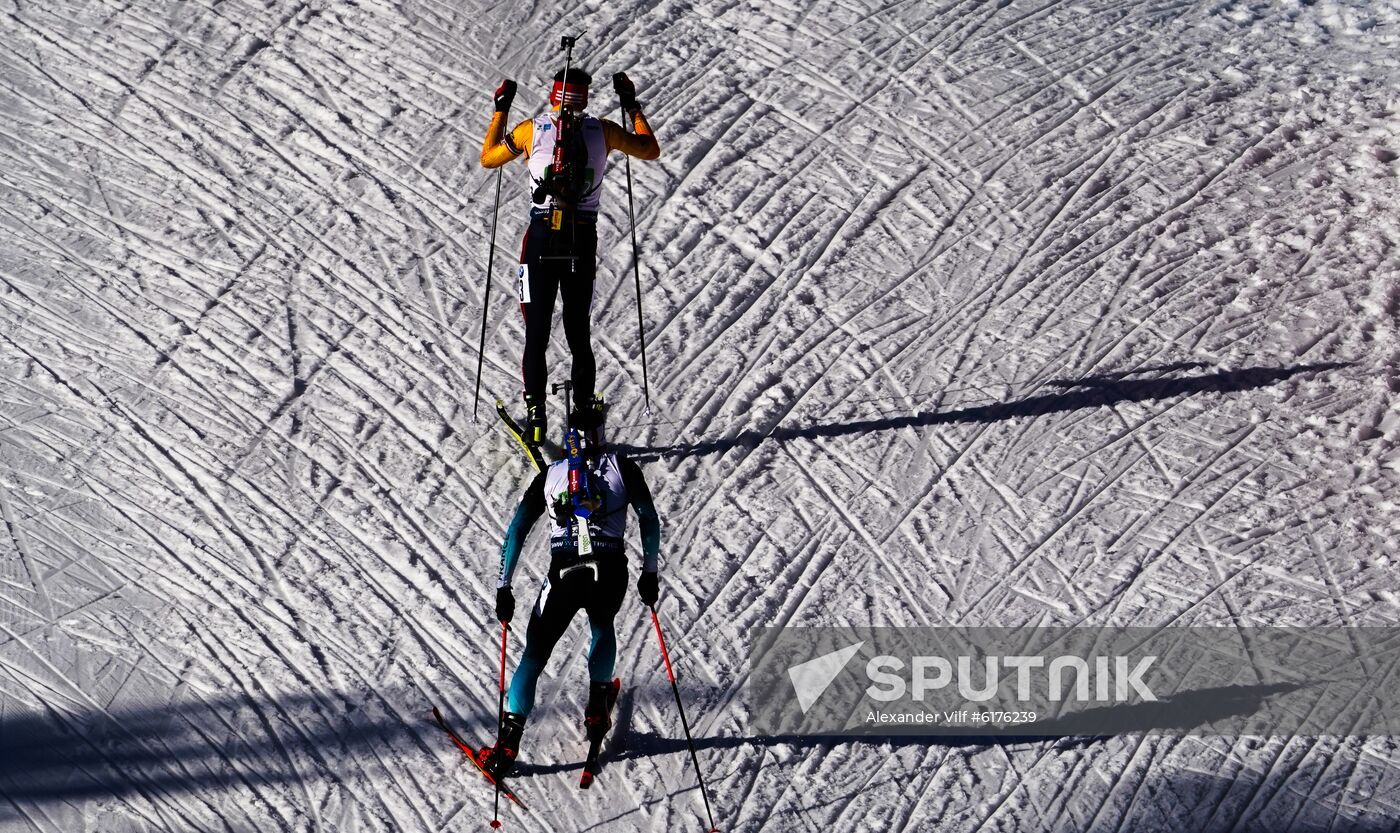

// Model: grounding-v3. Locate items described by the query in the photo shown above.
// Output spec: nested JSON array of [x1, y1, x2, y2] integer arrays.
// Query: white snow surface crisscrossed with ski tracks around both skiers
[[0, 0, 1400, 833]]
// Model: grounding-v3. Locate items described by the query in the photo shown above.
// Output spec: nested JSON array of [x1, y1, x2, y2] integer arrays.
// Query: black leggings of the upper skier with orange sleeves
[[515, 217, 598, 402]]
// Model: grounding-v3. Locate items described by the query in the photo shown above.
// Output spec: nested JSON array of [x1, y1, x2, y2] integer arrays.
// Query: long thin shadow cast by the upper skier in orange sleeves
[[616, 361, 1352, 462]]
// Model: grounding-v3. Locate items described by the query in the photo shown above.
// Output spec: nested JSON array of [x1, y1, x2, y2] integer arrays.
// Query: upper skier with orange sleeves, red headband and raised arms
[[482, 67, 661, 448]]
